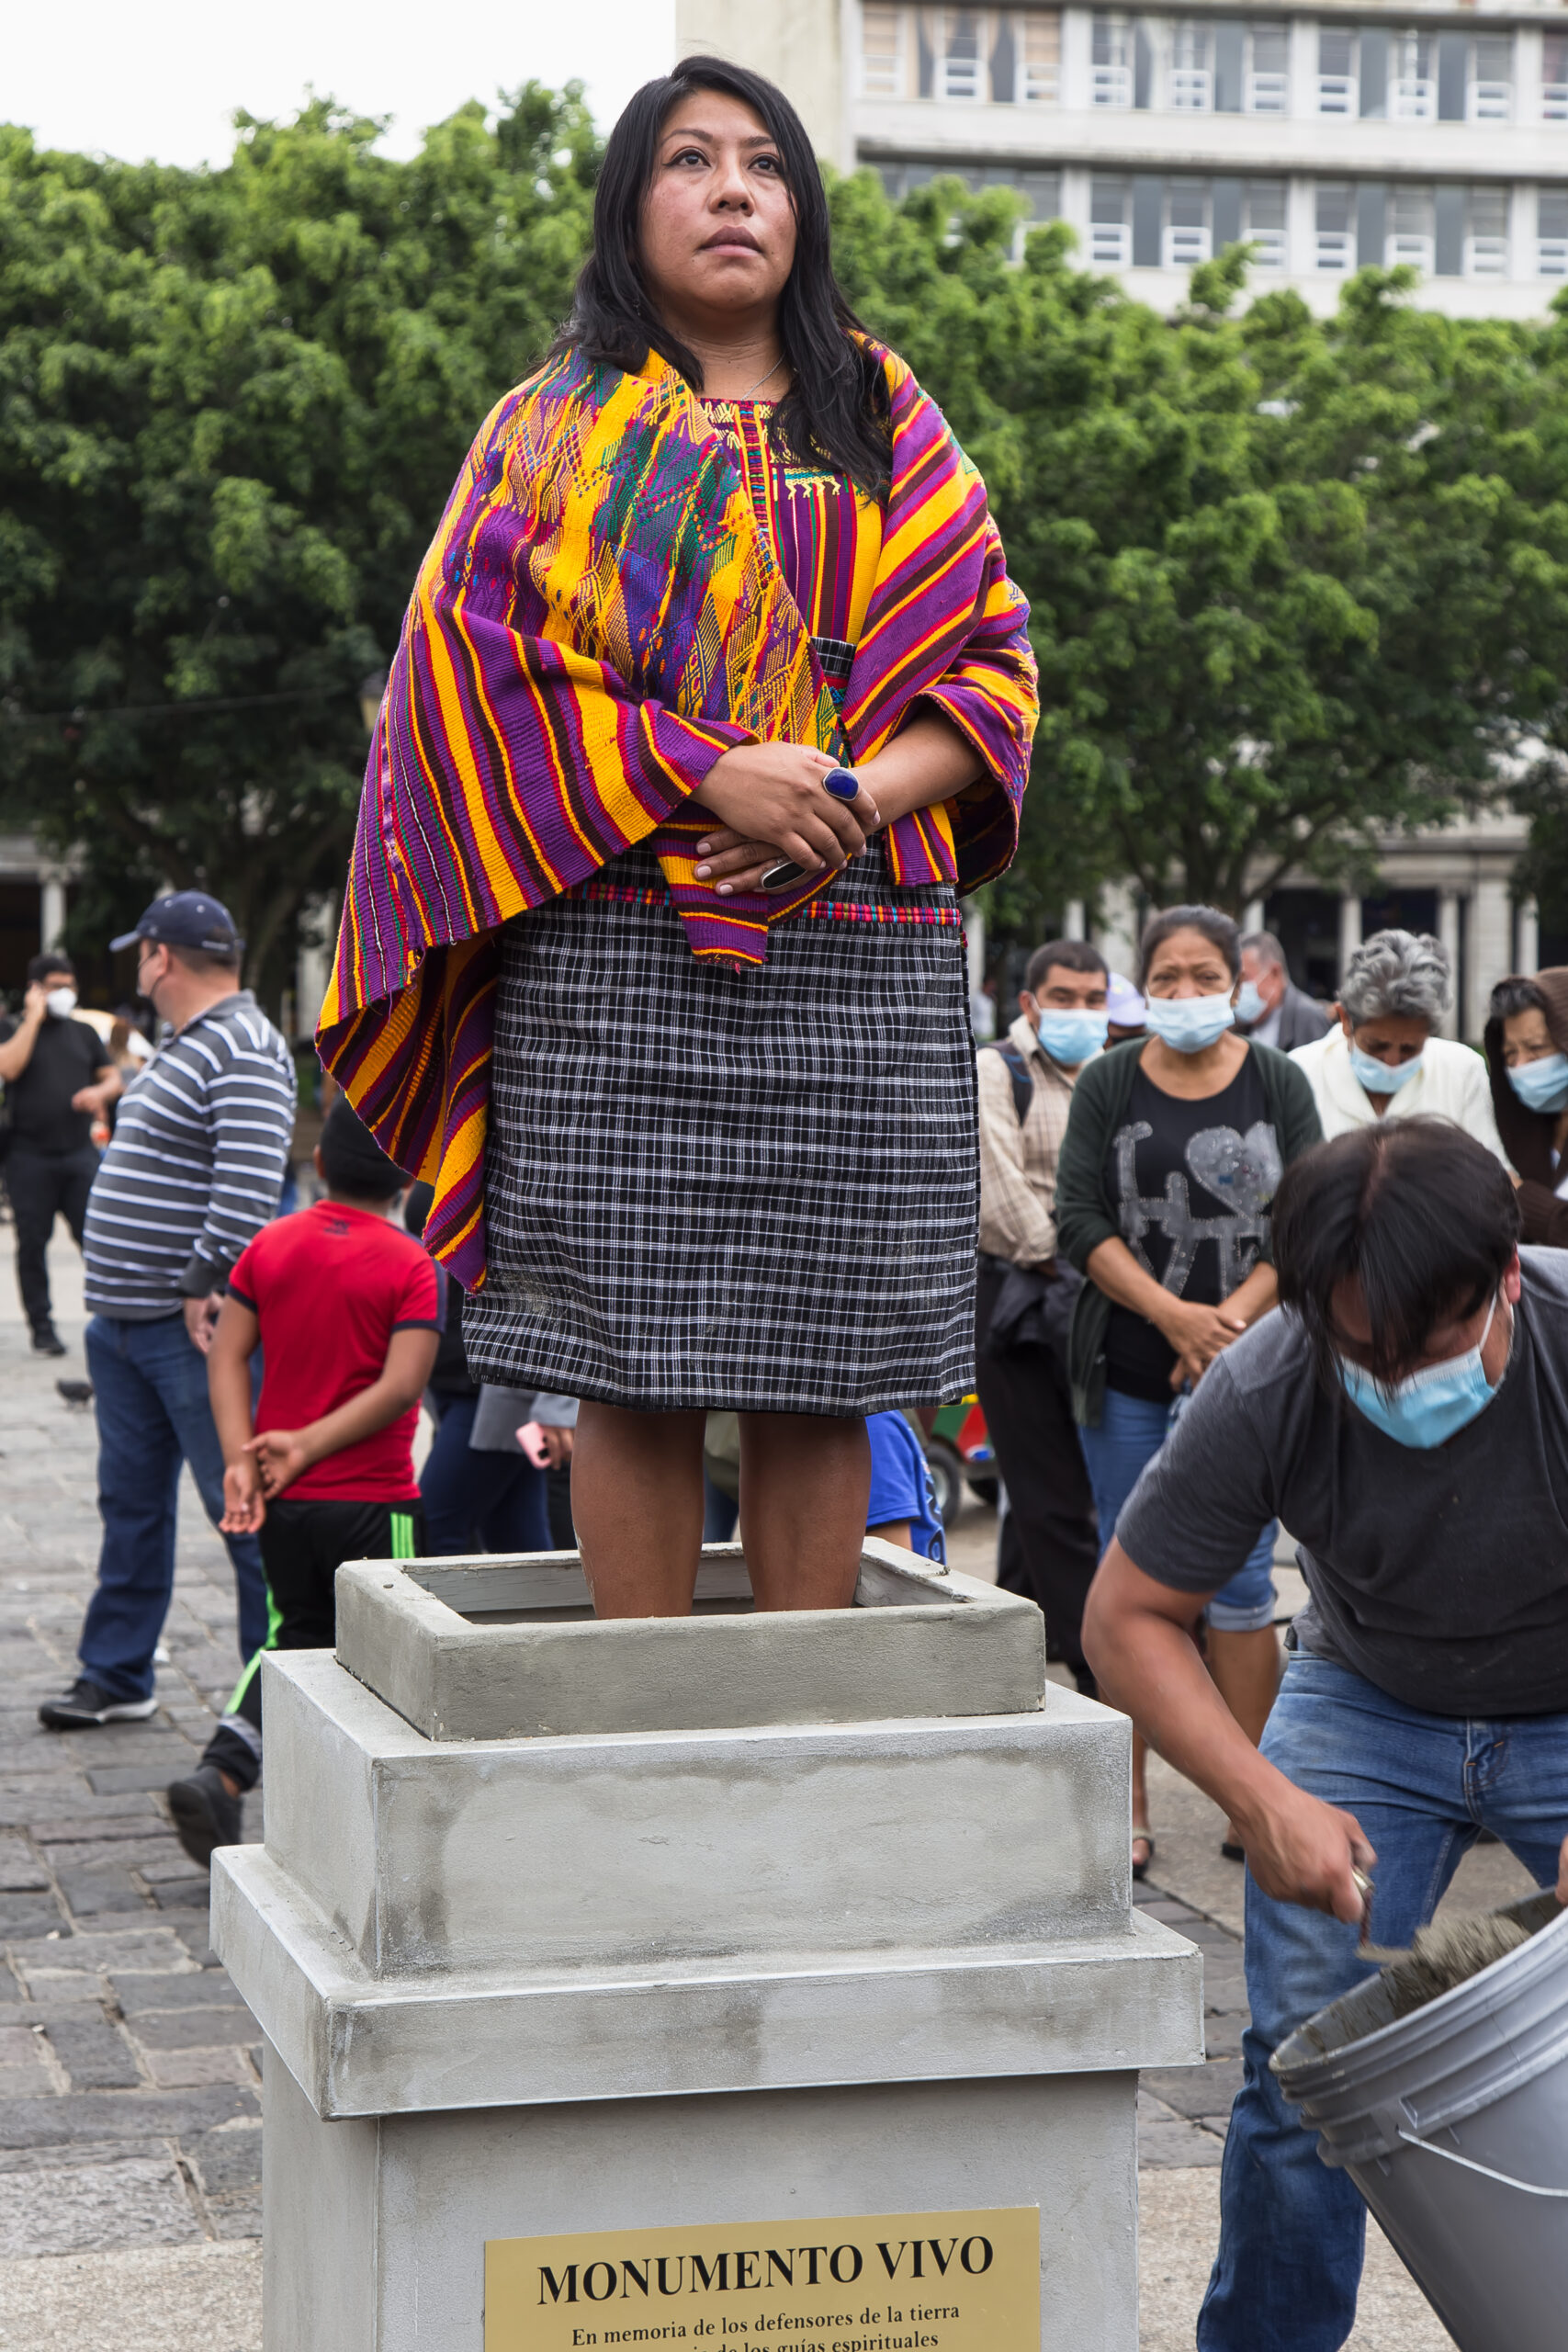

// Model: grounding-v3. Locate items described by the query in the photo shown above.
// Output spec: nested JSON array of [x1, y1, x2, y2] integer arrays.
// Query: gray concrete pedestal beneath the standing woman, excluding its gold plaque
[[214, 1545, 1201, 2352]]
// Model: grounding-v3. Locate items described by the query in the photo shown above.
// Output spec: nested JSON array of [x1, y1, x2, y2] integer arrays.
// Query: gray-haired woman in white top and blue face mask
[[1291, 932, 1506, 1167]]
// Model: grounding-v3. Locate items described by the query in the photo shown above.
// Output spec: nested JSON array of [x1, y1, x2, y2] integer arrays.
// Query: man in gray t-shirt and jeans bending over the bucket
[[1084, 1117, 1568, 2352]]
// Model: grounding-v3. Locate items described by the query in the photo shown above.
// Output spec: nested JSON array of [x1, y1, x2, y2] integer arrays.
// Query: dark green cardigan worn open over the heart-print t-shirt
[[1055, 1037, 1324, 1430]]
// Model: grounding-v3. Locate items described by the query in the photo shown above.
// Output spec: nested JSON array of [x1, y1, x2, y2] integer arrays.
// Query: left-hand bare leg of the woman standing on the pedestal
[[571, 1402, 707, 1616]]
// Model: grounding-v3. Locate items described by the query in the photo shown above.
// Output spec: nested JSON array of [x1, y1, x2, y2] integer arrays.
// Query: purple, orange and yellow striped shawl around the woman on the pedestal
[[317, 345, 1037, 1289]]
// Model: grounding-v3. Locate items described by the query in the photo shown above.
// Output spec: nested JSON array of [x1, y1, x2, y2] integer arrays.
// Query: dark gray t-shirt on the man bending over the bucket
[[1117, 1249, 1568, 1717]]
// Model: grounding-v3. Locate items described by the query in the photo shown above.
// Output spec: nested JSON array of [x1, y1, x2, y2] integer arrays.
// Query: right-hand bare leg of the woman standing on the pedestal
[[740, 1414, 872, 1609]]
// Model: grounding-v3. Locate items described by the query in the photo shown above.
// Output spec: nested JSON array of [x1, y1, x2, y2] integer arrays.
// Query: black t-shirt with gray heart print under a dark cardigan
[[1105, 1054, 1283, 1404]]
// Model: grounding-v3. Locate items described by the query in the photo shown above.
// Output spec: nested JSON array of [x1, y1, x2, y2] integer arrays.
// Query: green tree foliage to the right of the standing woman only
[[832, 176, 1568, 910]]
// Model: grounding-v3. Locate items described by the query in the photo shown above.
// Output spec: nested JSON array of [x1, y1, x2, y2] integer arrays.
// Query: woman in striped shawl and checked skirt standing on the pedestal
[[322, 59, 1037, 1616]]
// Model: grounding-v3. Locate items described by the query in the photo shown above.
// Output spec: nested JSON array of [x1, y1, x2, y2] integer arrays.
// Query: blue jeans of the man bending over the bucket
[[1197, 1651, 1568, 2352]]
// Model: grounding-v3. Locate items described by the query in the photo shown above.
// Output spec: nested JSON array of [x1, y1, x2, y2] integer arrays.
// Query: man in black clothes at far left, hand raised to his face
[[0, 950, 120, 1355]]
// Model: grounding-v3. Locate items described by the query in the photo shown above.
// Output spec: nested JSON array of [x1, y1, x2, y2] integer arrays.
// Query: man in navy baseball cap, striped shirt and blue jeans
[[38, 889, 294, 1731]]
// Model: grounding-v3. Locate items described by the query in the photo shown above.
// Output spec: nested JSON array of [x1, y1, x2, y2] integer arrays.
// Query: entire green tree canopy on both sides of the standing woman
[[0, 85, 1568, 995]]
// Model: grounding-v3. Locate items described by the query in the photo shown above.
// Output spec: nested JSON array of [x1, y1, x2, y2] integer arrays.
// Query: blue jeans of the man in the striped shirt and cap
[[77, 1315, 268, 1698]]
